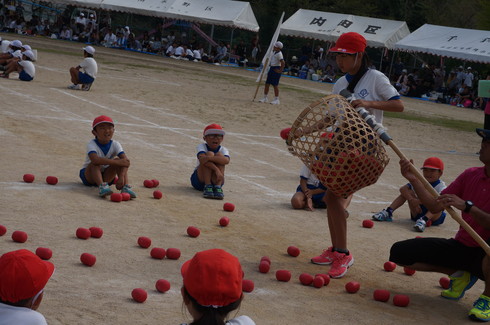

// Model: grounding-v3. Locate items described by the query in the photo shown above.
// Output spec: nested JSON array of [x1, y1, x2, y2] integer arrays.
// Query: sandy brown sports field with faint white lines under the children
[[0, 34, 483, 325]]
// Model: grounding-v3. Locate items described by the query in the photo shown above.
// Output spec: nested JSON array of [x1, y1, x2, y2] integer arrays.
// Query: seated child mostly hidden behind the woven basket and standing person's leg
[[291, 165, 327, 211]]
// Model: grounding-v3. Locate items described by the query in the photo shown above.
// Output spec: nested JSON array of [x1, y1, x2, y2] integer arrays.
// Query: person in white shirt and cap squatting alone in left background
[[68, 46, 98, 91]]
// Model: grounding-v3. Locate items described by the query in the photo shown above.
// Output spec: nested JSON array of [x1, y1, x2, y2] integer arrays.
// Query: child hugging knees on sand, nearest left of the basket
[[191, 124, 230, 200]]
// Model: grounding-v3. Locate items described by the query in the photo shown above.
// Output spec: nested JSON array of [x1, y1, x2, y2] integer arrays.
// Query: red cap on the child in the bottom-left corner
[[0, 249, 54, 303]]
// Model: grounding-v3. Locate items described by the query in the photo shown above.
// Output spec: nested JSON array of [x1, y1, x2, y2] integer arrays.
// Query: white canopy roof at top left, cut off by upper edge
[[50, 0, 259, 32]]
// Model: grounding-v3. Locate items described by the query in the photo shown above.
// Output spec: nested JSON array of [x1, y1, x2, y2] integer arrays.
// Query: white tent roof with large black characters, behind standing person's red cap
[[281, 9, 410, 49]]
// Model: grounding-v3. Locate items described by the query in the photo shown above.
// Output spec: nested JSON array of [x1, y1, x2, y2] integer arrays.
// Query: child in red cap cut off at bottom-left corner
[[0, 249, 54, 325]]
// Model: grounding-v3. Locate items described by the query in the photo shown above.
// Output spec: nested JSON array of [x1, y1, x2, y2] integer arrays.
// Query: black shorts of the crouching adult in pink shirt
[[390, 238, 486, 280]]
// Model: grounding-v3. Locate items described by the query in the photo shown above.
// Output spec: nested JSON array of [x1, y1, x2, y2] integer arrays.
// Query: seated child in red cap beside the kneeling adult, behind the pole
[[373, 157, 446, 232]]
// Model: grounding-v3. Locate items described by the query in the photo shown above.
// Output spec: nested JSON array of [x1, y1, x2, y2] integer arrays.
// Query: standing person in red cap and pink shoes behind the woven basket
[[295, 32, 404, 278]]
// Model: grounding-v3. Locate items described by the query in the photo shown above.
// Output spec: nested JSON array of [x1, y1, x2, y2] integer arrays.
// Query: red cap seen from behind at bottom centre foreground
[[181, 249, 243, 307]]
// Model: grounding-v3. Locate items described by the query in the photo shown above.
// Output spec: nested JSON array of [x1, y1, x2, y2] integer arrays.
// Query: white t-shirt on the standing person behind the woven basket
[[332, 69, 400, 124]]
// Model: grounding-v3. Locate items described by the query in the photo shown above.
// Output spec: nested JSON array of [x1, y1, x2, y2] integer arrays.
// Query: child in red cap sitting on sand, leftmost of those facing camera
[[80, 115, 136, 199]]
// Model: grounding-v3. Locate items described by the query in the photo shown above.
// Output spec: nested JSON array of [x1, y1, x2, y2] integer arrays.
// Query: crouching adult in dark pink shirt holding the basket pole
[[390, 129, 490, 321]]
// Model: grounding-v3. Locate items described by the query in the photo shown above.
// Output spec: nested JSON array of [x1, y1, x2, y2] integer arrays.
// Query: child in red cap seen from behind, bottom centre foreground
[[181, 249, 255, 325]]
